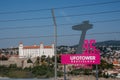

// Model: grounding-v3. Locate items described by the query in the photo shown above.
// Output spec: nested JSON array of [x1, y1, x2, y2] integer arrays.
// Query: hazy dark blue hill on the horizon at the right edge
[[96, 40, 120, 46]]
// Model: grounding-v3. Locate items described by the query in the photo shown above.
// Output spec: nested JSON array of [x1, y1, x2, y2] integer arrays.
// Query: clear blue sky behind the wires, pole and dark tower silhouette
[[0, 0, 120, 48]]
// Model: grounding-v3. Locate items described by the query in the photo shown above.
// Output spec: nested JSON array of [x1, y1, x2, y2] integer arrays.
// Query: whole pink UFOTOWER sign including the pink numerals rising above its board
[[61, 39, 100, 65]]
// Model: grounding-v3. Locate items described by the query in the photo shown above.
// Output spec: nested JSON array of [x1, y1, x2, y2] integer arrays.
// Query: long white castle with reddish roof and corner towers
[[19, 43, 54, 58]]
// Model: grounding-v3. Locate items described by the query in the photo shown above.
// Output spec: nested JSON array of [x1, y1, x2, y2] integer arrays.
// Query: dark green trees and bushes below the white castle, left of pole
[[0, 64, 54, 78]]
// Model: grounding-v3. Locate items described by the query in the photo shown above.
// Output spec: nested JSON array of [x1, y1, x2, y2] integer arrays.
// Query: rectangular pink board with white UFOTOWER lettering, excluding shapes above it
[[61, 54, 100, 64]]
